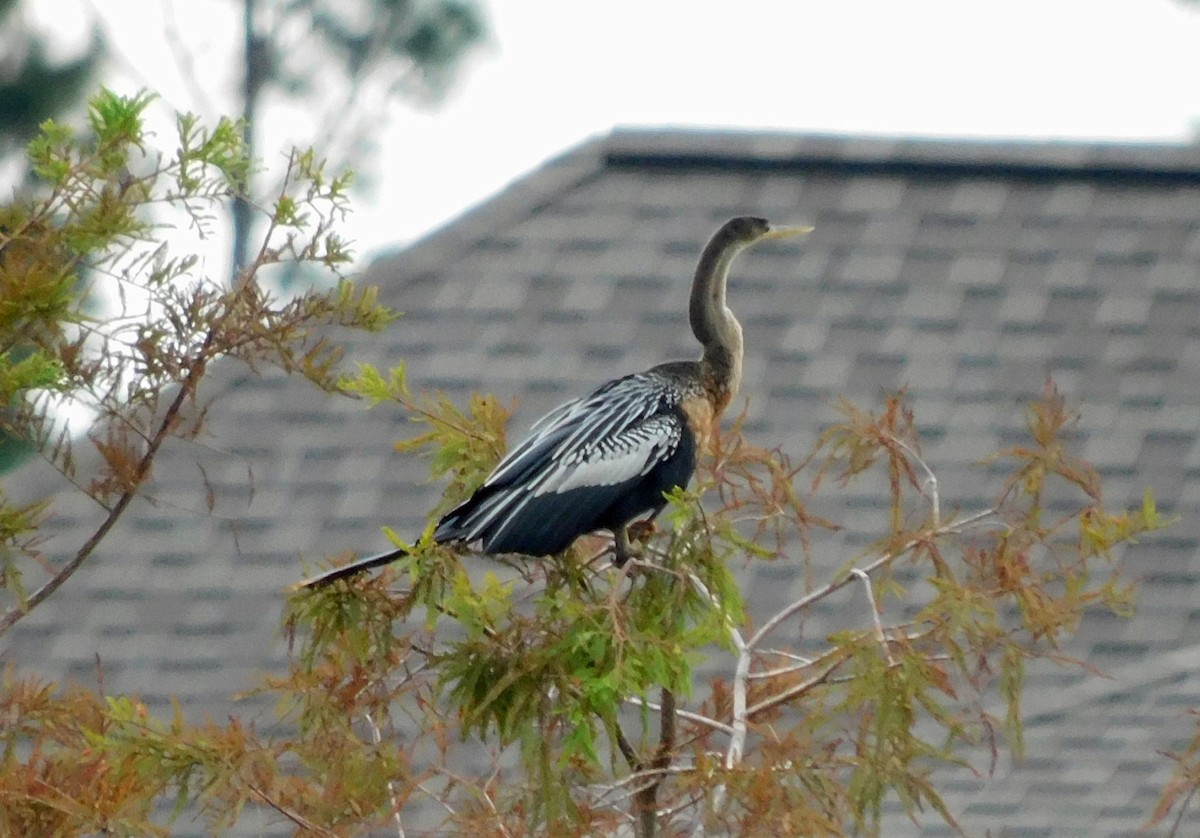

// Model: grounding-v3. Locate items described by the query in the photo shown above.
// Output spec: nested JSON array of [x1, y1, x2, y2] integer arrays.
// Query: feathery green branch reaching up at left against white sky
[[0, 90, 394, 632]]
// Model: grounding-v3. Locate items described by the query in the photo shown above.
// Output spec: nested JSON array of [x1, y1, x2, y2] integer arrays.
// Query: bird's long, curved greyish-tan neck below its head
[[688, 228, 744, 413]]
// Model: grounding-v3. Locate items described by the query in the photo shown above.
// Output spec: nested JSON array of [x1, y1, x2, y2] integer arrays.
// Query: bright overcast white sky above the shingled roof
[[34, 0, 1200, 256]]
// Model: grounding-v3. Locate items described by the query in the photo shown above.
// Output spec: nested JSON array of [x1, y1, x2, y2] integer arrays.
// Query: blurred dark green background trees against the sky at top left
[[0, 0, 487, 280]]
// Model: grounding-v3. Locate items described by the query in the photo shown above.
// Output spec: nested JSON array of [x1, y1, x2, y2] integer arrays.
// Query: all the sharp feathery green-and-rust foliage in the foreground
[[0, 92, 1171, 837]]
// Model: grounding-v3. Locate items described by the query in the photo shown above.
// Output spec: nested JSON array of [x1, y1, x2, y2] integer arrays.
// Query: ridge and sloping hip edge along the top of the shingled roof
[[366, 127, 1200, 290]]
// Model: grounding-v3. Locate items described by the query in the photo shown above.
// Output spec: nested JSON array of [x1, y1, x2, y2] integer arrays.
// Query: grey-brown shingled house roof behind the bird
[[9, 131, 1200, 837]]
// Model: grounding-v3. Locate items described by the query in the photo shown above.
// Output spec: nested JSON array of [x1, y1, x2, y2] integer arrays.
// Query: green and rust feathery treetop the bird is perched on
[[274, 381, 1165, 834]]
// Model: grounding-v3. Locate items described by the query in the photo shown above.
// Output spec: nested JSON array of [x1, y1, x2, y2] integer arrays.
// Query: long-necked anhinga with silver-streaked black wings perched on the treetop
[[296, 217, 811, 587]]
